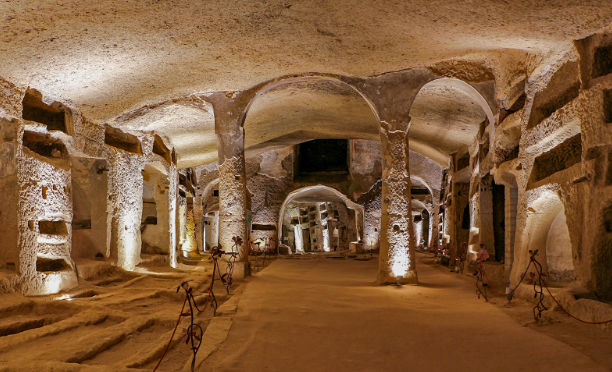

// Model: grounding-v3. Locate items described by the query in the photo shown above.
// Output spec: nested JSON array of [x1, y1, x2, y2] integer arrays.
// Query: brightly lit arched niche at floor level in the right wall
[[521, 190, 575, 281]]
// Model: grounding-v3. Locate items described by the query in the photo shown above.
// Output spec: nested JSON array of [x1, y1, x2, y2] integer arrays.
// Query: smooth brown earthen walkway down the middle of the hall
[[200, 256, 607, 372]]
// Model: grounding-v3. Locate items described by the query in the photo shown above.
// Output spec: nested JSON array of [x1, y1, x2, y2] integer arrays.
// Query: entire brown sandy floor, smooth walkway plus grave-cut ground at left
[[0, 254, 612, 372]]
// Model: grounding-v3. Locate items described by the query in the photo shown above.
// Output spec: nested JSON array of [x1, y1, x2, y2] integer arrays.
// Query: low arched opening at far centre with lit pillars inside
[[277, 185, 364, 253]]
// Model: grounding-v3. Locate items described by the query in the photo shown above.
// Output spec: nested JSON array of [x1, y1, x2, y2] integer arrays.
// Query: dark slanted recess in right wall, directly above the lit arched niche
[[532, 134, 582, 182]]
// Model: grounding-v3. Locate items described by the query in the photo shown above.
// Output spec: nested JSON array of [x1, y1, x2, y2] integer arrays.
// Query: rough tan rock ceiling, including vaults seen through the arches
[[0, 0, 612, 166]]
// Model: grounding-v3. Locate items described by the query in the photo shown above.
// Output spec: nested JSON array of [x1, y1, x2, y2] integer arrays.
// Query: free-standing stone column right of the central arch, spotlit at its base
[[377, 122, 418, 284]]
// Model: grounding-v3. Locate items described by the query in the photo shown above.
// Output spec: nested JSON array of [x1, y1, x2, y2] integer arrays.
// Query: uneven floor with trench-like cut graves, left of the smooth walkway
[[0, 265, 228, 372]]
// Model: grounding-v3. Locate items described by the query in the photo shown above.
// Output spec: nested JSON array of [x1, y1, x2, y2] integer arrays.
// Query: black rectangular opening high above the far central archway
[[298, 139, 348, 175]]
